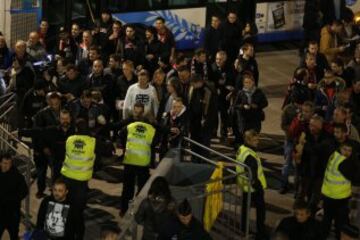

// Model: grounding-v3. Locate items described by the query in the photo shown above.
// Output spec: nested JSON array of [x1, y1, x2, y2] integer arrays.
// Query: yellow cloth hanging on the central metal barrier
[[204, 162, 224, 231]]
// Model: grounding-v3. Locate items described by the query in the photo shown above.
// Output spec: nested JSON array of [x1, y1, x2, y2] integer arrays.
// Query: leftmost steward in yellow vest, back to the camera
[[61, 119, 96, 239]]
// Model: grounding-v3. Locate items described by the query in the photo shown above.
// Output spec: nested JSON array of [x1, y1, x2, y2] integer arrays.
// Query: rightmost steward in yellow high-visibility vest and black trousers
[[321, 141, 352, 239]]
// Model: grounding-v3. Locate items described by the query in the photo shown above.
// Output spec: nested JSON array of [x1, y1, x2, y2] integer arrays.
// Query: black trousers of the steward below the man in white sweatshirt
[[121, 164, 150, 213]]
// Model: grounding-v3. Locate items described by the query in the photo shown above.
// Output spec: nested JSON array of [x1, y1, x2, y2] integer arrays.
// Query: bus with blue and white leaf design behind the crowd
[[42, 0, 256, 49]]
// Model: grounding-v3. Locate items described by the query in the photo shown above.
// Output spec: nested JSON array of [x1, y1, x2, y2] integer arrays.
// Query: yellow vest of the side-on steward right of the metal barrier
[[236, 145, 267, 192]]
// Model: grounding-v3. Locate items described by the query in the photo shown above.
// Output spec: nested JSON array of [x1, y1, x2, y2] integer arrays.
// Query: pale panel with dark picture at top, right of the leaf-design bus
[[256, 0, 305, 33]]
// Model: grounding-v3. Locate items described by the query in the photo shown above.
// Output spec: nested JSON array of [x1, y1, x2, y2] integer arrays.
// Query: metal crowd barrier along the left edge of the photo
[[0, 93, 32, 230]]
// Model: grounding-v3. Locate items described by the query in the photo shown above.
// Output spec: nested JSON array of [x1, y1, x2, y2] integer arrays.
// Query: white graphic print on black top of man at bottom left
[[45, 202, 70, 237]]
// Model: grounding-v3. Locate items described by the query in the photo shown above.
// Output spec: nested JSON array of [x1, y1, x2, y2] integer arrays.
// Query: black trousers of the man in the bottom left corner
[[0, 209, 20, 240]]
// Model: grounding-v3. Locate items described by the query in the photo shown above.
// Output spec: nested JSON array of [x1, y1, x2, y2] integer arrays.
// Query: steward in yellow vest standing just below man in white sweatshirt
[[120, 102, 157, 216]]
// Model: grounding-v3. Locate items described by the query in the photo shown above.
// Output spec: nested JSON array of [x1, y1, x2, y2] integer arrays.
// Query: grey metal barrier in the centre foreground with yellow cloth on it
[[118, 137, 252, 240]]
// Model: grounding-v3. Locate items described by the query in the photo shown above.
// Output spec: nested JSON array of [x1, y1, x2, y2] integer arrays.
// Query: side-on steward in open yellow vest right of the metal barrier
[[236, 129, 268, 240]]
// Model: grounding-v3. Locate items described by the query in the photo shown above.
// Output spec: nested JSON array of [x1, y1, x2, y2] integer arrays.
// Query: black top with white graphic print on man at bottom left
[[36, 196, 80, 240]]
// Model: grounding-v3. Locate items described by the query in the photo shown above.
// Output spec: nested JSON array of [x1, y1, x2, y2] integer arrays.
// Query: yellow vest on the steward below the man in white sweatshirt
[[124, 122, 155, 167]]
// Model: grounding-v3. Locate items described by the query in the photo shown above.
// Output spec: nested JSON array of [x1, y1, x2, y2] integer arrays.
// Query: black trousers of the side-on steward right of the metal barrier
[[241, 190, 268, 240]]
